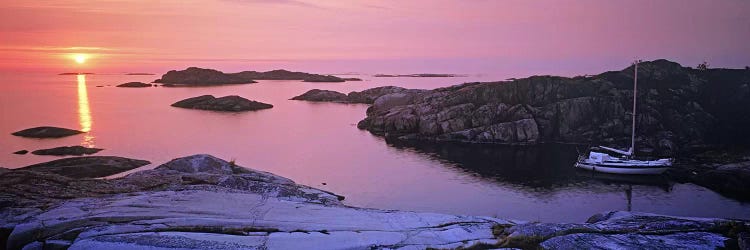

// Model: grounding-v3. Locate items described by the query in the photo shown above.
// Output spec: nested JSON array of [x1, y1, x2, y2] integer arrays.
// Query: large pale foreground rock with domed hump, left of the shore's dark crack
[[0, 155, 511, 249]]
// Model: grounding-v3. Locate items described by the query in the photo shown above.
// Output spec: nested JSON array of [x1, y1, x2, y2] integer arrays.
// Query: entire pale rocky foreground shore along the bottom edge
[[0, 155, 750, 249]]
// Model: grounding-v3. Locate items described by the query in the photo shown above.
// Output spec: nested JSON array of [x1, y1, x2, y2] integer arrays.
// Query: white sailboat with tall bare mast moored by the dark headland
[[575, 61, 672, 175]]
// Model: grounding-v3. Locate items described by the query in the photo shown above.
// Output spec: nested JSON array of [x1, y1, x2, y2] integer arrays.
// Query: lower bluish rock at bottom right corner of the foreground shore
[[495, 212, 750, 249]]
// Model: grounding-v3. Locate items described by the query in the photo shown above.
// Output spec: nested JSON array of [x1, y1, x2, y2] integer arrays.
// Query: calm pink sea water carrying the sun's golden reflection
[[0, 74, 750, 222]]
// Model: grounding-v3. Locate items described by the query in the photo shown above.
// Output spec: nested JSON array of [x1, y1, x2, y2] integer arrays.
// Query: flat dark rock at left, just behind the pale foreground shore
[[19, 156, 151, 178]]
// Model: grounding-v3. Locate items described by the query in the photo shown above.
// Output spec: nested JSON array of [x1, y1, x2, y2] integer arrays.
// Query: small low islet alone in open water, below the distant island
[[172, 95, 273, 112]]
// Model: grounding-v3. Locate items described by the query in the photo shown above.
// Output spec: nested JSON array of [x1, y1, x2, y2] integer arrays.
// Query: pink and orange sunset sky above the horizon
[[0, 0, 750, 77]]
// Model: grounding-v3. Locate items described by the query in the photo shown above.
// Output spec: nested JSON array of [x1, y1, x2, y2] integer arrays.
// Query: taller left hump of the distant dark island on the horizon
[[154, 67, 255, 85]]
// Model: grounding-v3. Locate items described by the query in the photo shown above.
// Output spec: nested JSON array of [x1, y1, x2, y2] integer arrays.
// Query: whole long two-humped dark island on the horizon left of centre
[[154, 67, 360, 85]]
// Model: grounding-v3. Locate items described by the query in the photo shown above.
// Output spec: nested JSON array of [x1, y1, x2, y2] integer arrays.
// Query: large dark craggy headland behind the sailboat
[[358, 60, 750, 156]]
